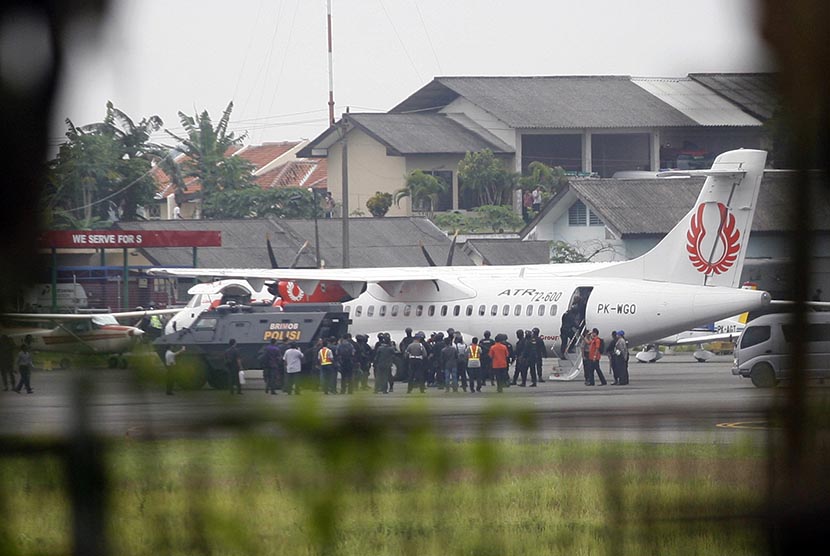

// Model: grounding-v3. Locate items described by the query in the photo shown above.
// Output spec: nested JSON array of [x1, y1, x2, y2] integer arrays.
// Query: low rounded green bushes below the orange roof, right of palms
[[202, 187, 321, 218]]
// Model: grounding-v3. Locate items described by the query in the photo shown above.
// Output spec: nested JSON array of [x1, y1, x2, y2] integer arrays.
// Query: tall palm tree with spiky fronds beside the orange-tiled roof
[[165, 102, 254, 214]]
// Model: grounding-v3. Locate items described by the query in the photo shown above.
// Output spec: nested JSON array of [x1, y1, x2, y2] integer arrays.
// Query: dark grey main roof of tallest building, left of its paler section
[[391, 76, 698, 129]]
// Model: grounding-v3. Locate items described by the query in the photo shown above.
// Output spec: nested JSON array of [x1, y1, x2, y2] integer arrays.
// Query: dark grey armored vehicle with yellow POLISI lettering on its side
[[153, 303, 349, 389]]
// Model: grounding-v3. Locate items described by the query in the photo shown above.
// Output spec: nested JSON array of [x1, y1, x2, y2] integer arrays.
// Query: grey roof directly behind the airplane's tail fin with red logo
[[564, 174, 830, 237]]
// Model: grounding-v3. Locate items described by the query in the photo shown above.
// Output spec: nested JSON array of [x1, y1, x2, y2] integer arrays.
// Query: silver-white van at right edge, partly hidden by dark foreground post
[[732, 313, 830, 388]]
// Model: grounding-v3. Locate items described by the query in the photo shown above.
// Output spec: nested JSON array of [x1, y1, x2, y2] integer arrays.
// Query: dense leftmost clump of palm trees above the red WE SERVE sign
[[43, 102, 166, 228]]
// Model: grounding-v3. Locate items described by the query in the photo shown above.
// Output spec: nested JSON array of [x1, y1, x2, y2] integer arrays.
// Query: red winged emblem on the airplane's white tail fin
[[686, 203, 741, 275]]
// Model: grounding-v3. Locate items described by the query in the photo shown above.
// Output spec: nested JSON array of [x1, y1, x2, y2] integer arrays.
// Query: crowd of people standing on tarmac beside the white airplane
[[208, 328, 628, 395]]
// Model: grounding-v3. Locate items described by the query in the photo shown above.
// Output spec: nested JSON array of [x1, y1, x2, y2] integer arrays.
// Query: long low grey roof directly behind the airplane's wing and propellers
[[121, 217, 472, 268]]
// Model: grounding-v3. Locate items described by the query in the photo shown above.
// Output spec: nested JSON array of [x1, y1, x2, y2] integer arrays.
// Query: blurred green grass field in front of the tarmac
[[0, 404, 766, 556]]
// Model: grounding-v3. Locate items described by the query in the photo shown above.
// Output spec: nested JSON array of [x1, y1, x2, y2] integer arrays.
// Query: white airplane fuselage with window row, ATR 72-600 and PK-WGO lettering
[[346, 272, 769, 349]]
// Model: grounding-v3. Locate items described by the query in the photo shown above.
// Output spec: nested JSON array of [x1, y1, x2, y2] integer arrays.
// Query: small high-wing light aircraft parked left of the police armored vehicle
[[0, 309, 181, 368]]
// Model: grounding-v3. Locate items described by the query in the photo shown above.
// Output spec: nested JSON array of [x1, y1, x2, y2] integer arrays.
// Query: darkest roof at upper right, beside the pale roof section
[[689, 73, 780, 120]]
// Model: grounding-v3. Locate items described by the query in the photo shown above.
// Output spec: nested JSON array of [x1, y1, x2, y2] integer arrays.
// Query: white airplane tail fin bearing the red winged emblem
[[596, 149, 767, 287]]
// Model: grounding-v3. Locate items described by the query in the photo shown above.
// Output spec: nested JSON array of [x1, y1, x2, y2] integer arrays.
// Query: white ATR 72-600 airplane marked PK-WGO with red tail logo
[[148, 149, 770, 377]]
